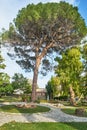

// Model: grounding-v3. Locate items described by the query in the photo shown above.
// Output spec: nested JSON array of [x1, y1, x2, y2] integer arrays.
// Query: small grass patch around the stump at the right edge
[[61, 107, 87, 117]]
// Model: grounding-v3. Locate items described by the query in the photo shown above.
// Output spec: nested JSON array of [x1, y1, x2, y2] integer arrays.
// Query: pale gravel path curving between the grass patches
[[0, 104, 87, 126]]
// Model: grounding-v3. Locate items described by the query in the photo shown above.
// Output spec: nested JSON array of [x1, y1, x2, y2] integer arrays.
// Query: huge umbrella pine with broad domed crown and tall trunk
[[2, 2, 87, 101]]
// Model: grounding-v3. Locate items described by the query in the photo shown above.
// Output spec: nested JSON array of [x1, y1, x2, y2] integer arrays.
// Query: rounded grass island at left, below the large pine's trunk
[[0, 105, 50, 113]]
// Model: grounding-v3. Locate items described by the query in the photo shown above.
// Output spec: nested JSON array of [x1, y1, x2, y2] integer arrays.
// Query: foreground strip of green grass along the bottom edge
[[0, 122, 87, 130]]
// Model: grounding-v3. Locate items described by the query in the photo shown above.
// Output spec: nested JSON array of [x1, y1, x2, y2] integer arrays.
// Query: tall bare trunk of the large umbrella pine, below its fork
[[31, 59, 40, 102]]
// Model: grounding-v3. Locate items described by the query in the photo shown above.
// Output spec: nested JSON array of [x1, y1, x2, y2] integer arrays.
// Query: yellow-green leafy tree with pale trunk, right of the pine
[[56, 48, 83, 105]]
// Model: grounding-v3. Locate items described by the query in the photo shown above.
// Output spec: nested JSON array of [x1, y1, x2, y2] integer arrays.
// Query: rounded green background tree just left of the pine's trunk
[[12, 73, 31, 93]]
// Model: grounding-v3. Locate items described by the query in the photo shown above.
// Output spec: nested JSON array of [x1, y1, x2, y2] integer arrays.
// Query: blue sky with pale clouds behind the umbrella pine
[[0, 0, 87, 87]]
